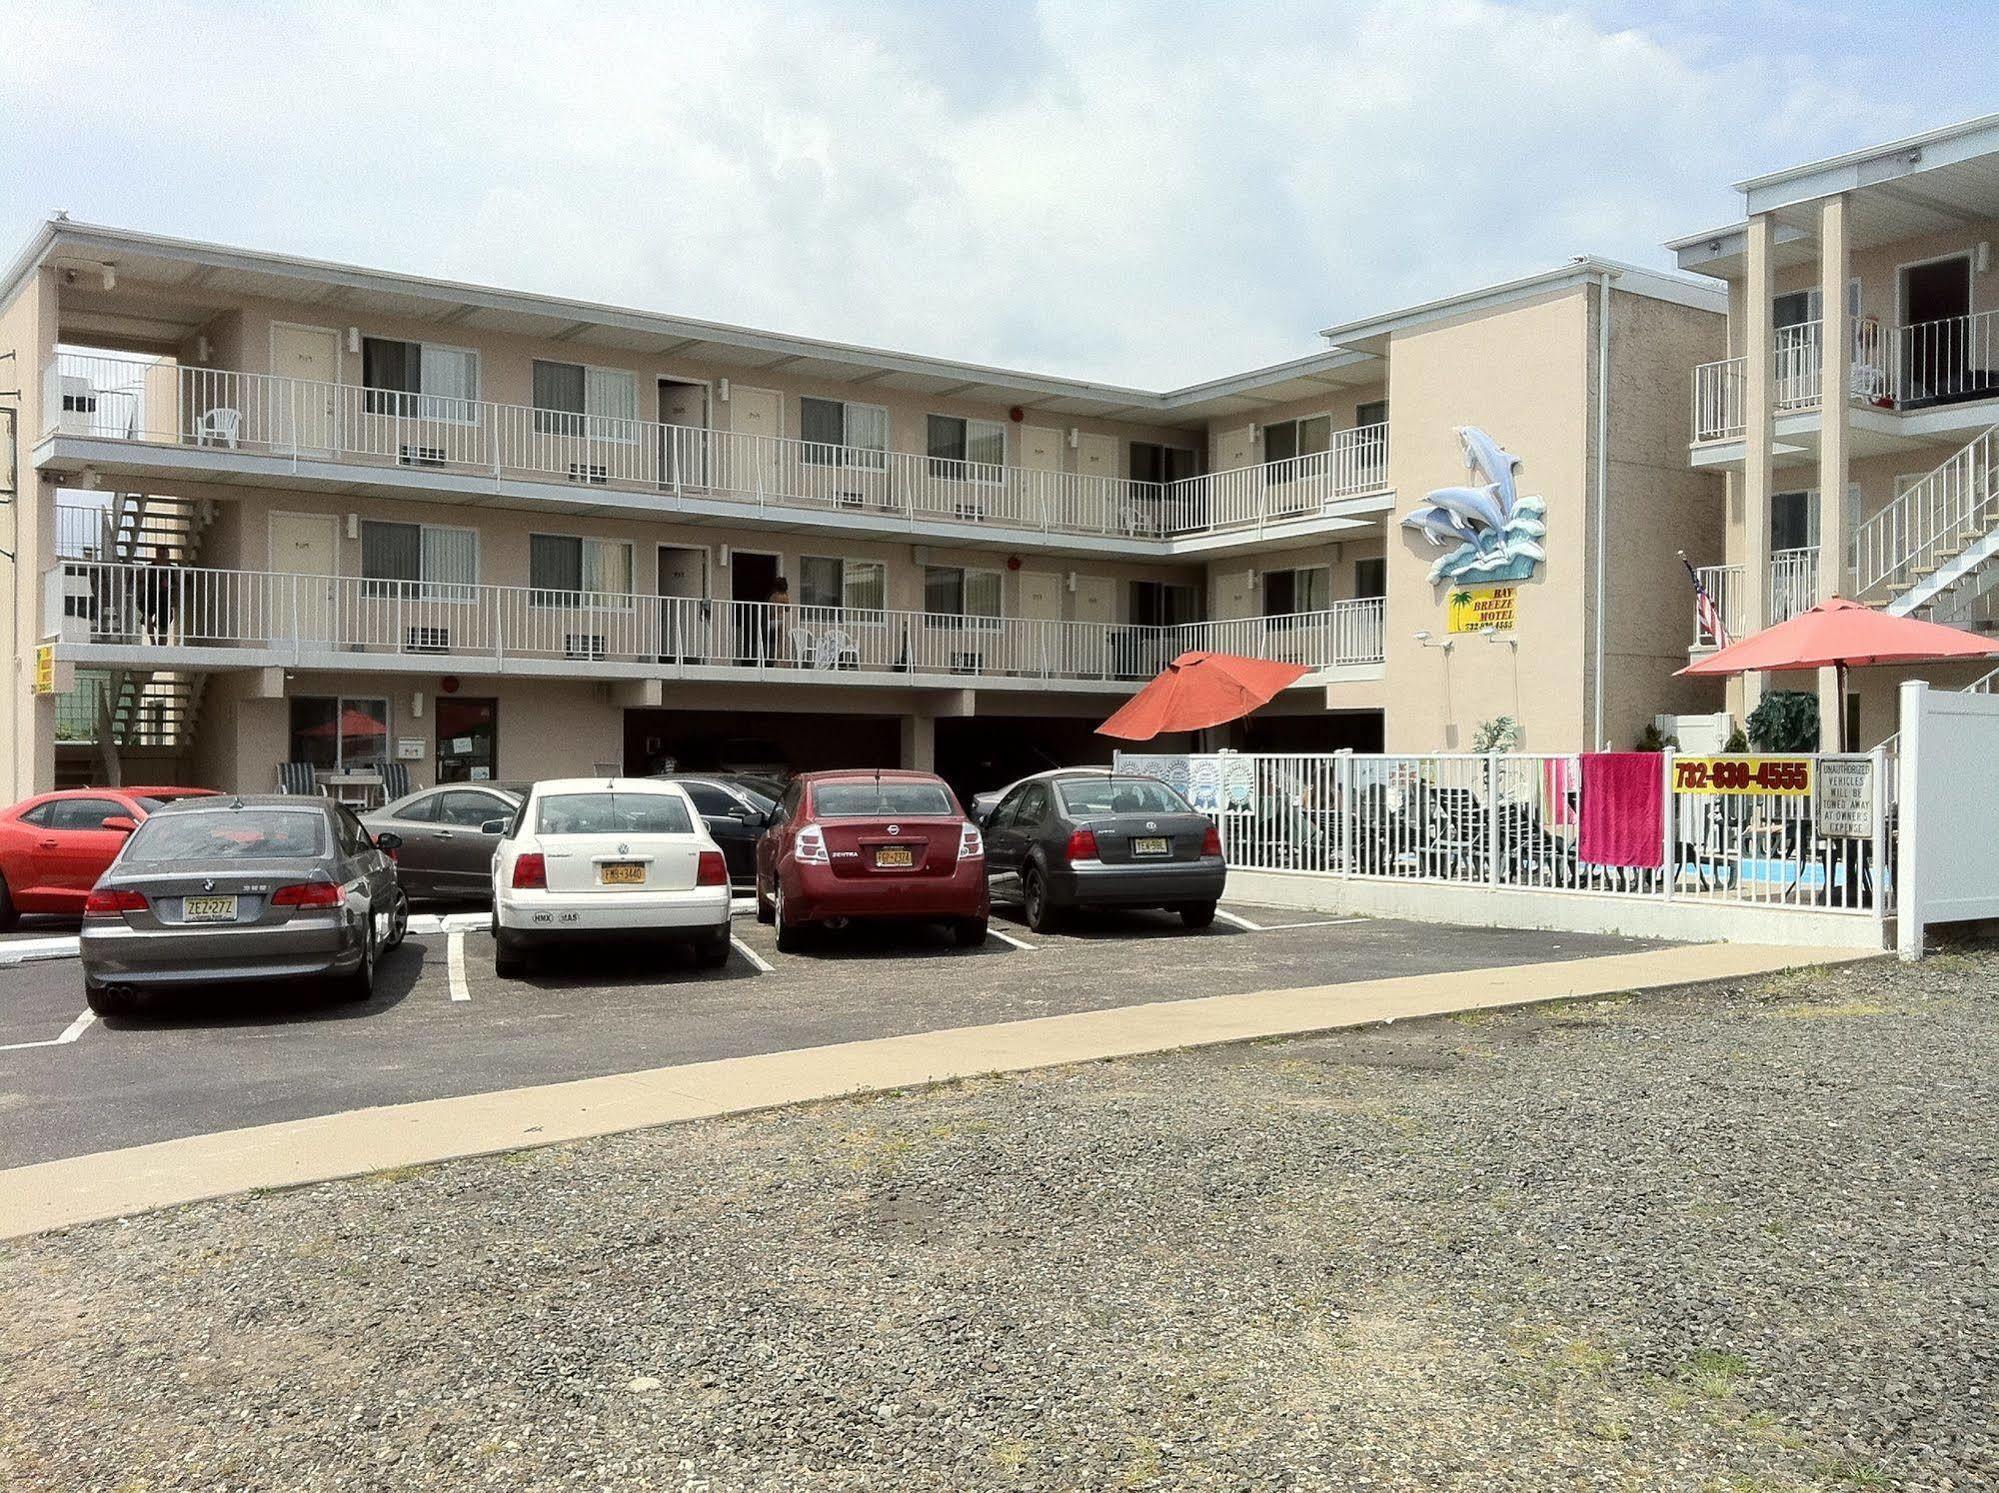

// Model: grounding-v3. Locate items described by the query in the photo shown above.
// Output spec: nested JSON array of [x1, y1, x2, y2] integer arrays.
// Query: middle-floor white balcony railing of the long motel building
[[44, 562, 1381, 682]]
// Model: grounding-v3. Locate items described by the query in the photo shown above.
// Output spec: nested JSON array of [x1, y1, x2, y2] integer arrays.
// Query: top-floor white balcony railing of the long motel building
[[44, 352, 1387, 538]]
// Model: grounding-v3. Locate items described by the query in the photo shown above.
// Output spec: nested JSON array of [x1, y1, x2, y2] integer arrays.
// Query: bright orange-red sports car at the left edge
[[0, 787, 210, 927]]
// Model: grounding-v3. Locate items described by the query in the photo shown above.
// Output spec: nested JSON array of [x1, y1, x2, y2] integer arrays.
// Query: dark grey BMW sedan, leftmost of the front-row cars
[[82, 795, 410, 1015]]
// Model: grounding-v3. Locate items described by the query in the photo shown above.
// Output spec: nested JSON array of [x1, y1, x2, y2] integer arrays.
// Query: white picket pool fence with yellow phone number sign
[[1117, 751, 1893, 913]]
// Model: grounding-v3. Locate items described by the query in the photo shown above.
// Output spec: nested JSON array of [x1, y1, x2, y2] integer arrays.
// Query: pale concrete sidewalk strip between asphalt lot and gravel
[[0, 943, 1879, 1237]]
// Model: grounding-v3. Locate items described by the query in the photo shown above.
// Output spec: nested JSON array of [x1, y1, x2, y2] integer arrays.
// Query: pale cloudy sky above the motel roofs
[[0, 0, 1999, 388]]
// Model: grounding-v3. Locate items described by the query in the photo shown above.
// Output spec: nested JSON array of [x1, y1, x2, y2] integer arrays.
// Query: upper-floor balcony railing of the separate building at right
[[1693, 312, 1999, 442]]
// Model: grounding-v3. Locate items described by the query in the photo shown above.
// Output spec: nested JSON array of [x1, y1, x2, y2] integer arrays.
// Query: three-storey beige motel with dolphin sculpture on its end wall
[[0, 218, 1727, 797]]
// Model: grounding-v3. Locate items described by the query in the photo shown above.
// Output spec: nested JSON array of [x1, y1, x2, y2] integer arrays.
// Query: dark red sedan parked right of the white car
[[756, 771, 992, 951]]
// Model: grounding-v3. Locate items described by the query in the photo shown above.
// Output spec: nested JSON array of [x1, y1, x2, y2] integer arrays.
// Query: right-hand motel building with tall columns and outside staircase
[[1669, 114, 1999, 749]]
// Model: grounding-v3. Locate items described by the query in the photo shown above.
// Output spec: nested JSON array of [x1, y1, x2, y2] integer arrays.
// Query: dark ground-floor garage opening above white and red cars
[[624, 710, 902, 775]]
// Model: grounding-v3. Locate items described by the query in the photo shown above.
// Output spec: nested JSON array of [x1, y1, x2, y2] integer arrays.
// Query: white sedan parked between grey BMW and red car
[[494, 777, 730, 975]]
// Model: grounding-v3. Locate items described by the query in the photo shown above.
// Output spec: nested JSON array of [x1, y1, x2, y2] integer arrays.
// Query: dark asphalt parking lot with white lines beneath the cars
[[0, 903, 1671, 1167]]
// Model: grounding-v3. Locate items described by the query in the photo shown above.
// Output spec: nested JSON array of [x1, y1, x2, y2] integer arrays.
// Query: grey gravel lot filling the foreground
[[0, 955, 1999, 1493]]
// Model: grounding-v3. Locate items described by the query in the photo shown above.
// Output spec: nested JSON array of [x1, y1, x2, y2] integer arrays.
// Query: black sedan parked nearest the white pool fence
[[986, 767, 1227, 931]]
